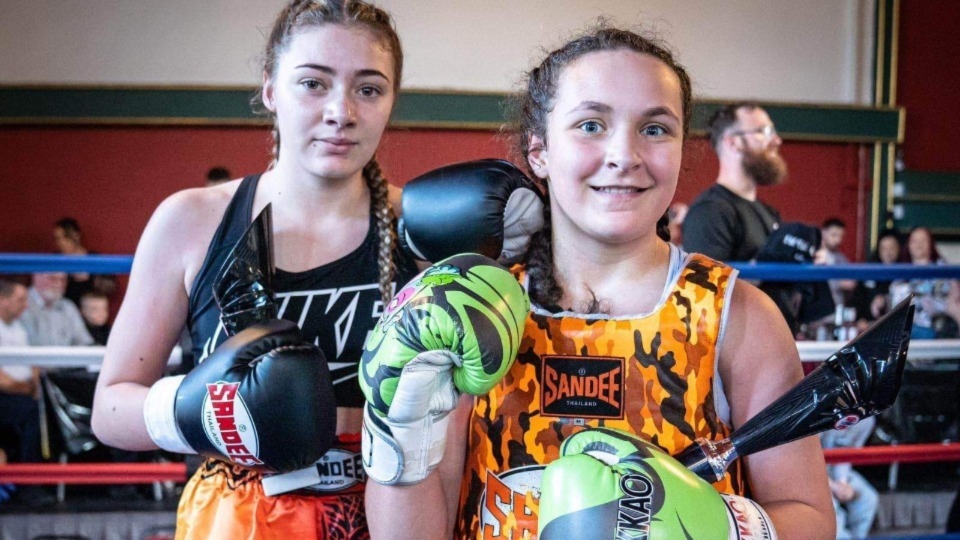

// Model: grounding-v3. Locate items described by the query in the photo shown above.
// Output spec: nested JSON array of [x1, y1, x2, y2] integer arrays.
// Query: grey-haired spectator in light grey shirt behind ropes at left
[[22, 272, 93, 346]]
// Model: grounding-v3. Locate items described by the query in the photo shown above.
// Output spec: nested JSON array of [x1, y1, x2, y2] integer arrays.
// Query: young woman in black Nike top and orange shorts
[[93, 0, 416, 539]]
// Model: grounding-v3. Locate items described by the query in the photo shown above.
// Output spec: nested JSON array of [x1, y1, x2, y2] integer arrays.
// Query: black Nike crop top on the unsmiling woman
[[187, 174, 417, 407]]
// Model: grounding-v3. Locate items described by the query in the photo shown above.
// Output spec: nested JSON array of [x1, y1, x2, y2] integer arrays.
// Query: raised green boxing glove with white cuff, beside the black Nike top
[[360, 253, 530, 485]]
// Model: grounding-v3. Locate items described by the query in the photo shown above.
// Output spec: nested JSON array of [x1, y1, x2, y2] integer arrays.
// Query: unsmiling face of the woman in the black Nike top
[[263, 24, 396, 179]]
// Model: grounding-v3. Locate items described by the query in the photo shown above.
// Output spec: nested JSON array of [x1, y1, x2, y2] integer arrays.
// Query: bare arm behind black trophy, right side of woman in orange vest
[[720, 280, 836, 540]]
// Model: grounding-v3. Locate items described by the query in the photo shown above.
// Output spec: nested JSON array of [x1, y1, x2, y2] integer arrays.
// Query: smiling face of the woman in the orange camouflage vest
[[529, 49, 683, 244]]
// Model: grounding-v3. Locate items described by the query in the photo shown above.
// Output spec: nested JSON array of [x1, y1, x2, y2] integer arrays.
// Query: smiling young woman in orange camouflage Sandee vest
[[367, 24, 835, 540]]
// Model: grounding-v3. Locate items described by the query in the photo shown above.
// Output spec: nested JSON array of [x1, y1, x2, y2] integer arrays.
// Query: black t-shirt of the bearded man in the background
[[683, 184, 780, 262]]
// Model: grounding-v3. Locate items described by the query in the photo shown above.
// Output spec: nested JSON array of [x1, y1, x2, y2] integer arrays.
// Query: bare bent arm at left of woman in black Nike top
[[92, 190, 217, 450]]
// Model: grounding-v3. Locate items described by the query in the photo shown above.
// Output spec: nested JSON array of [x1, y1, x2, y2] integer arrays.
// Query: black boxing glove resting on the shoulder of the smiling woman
[[398, 159, 544, 265]]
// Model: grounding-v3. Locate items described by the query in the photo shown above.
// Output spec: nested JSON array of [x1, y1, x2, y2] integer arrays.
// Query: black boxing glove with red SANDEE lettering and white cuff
[[143, 320, 337, 472]]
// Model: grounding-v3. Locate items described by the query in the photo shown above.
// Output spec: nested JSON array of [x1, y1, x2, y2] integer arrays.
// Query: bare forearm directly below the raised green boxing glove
[[366, 396, 473, 540]]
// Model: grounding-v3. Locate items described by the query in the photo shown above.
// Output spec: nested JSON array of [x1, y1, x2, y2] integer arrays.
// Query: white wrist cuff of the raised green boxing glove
[[361, 403, 450, 485]]
